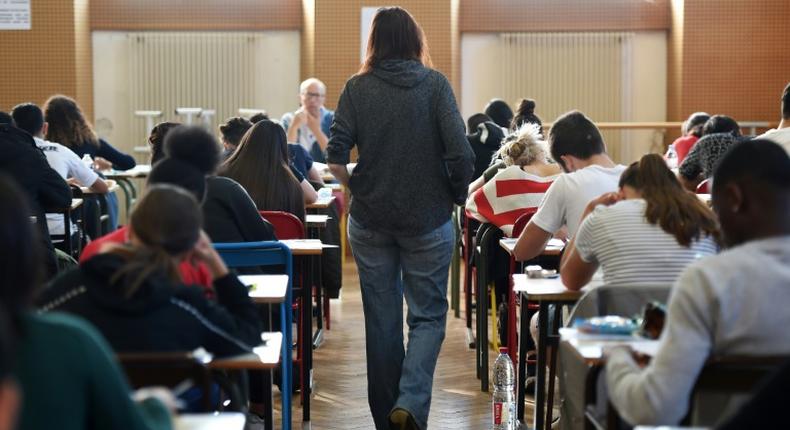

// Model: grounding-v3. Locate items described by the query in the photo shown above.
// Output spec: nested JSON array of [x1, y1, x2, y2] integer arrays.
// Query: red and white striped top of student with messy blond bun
[[466, 166, 559, 236]]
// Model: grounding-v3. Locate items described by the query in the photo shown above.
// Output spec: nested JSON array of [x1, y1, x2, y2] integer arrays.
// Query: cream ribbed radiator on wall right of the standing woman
[[499, 32, 634, 159]]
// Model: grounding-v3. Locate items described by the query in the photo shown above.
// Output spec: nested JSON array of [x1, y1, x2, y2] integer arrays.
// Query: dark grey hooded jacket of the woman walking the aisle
[[327, 60, 474, 236]]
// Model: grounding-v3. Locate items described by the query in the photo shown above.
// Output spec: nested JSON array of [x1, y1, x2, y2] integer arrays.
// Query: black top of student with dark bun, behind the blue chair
[[202, 176, 277, 242]]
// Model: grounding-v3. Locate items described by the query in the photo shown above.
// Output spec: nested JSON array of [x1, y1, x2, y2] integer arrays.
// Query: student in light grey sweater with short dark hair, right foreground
[[606, 140, 790, 425]]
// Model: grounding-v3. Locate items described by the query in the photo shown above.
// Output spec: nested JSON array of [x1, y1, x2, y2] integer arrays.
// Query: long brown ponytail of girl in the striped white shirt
[[620, 154, 719, 247]]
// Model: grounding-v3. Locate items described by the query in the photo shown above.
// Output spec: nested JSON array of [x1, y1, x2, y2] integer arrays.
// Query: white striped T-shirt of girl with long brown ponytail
[[576, 199, 718, 286]]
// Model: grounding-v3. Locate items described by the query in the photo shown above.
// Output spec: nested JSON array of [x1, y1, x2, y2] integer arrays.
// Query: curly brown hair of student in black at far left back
[[44, 95, 99, 148]]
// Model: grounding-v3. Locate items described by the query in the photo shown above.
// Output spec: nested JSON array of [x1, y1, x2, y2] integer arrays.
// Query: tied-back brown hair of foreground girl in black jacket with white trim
[[110, 184, 203, 298]]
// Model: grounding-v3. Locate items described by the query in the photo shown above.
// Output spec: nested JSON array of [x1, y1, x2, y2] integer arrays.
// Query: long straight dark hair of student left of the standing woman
[[219, 120, 305, 221]]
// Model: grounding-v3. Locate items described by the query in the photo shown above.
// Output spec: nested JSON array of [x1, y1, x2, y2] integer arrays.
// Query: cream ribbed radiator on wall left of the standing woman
[[126, 32, 264, 149]]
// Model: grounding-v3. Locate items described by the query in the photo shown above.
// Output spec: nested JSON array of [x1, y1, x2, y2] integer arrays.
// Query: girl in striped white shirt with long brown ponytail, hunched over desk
[[560, 154, 718, 290]]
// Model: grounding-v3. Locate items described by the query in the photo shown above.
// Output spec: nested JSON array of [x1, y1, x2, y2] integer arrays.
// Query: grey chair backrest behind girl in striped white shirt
[[569, 285, 672, 326]]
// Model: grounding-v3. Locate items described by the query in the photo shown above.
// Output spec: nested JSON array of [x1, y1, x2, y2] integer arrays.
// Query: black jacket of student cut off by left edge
[[0, 124, 71, 276]]
